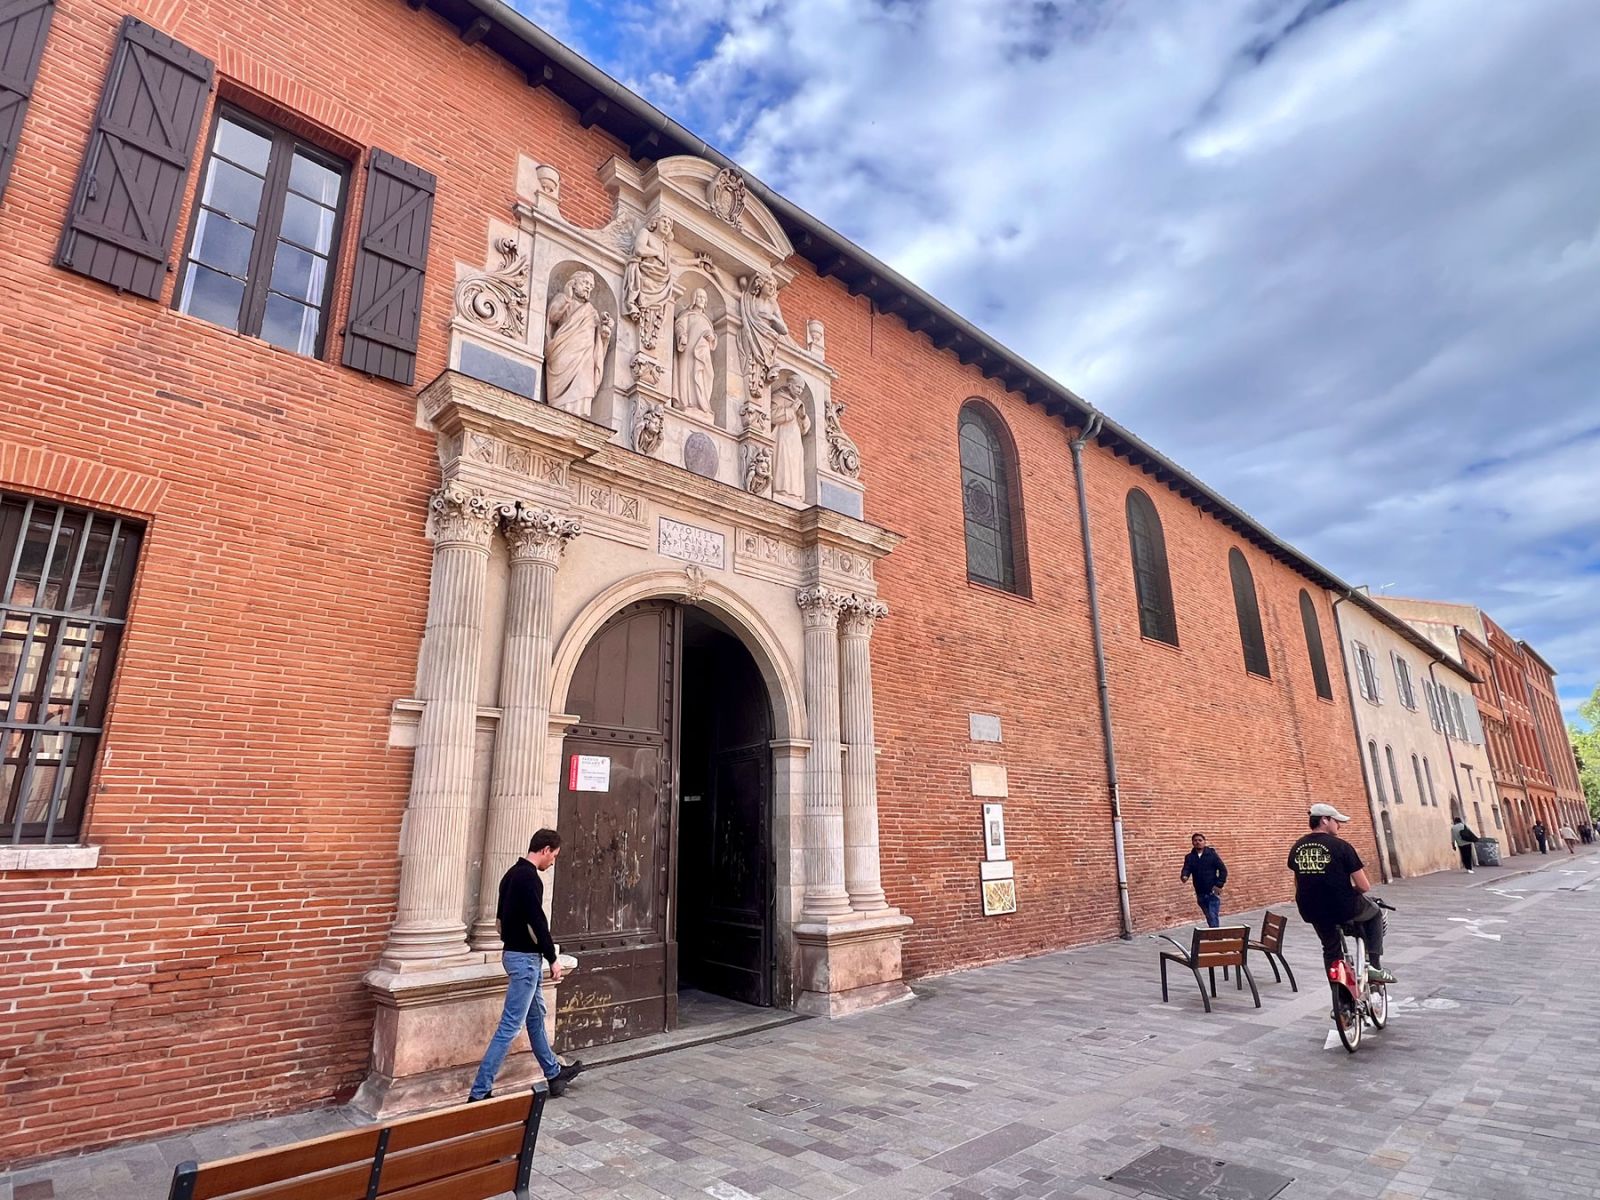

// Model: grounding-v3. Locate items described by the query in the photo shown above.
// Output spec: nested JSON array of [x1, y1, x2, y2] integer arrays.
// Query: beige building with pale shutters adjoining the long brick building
[[1336, 603, 1501, 877]]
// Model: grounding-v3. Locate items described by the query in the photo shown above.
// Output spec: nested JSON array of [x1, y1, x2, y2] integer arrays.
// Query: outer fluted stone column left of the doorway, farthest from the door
[[381, 483, 494, 970]]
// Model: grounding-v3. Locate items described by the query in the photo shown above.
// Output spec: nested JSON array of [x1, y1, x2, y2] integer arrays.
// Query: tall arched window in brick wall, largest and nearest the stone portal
[[957, 400, 1027, 595]]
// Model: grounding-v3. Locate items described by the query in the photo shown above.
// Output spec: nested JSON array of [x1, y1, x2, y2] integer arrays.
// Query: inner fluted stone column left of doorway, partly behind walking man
[[472, 501, 581, 952]]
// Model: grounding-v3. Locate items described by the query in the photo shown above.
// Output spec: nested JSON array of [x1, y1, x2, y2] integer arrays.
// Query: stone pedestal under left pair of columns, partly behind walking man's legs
[[350, 960, 555, 1118]]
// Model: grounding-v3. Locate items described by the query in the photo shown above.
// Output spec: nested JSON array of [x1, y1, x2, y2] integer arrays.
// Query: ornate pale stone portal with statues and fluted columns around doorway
[[358, 158, 910, 1112]]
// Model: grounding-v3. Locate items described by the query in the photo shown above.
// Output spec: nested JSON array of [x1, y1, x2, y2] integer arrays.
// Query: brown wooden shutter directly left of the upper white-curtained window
[[56, 16, 213, 299]]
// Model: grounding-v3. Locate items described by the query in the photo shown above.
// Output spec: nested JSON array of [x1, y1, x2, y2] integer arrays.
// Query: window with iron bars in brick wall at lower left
[[0, 493, 142, 845]]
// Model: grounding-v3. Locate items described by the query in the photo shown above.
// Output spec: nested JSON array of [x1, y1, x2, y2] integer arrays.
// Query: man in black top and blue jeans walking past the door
[[467, 829, 584, 1101]]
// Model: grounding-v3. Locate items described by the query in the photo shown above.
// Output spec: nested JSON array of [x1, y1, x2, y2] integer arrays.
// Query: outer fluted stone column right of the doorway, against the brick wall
[[838, 595, 890, 912]]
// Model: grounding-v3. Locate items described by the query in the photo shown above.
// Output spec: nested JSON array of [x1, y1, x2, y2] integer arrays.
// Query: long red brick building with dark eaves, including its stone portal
[[0, 0, 1536, 1160]]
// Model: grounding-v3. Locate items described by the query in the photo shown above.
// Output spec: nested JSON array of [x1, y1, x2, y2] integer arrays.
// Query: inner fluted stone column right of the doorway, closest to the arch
[[795, 587, 850, 920]]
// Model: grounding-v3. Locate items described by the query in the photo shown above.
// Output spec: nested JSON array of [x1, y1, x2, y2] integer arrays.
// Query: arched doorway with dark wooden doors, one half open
[[550, 598, 774, 1050]]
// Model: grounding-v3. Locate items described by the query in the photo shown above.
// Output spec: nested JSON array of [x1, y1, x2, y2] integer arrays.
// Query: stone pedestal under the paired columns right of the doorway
[[794, 909, 910, 1016]]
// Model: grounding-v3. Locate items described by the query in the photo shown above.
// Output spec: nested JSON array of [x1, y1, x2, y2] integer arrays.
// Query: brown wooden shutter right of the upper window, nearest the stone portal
[[344, 150, 437, 384]]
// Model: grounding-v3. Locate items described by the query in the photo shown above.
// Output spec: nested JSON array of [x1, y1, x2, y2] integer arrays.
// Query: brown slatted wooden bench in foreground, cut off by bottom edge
[[168, 1080, 549, 1200]]
